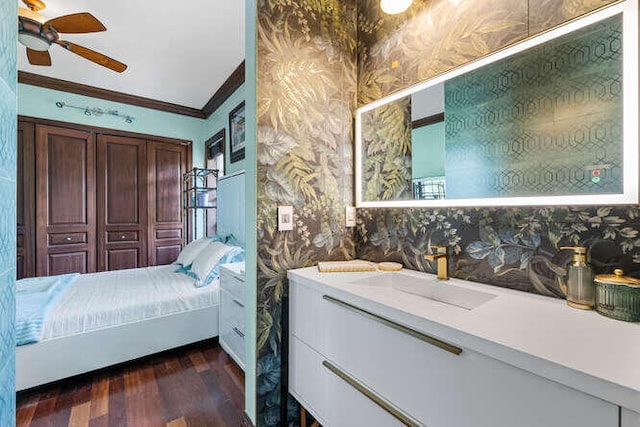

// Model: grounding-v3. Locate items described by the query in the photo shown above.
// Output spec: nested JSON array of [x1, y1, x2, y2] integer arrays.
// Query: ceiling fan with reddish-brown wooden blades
[[18, 0, 127, 73]]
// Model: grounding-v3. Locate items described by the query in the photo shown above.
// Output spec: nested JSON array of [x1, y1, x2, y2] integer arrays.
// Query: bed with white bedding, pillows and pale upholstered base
[[16, 238, 244, 390]]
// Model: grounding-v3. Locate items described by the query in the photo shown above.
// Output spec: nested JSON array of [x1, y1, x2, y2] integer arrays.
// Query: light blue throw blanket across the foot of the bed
[[16, 273, 79, 345]]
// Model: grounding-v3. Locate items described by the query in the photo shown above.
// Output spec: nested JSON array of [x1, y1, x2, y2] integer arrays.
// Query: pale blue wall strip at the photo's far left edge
[[0, 0, 18, 426]]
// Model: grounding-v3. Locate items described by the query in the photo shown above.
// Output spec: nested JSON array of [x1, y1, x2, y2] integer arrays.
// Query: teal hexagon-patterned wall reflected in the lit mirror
[[445, 16, 623, 198]]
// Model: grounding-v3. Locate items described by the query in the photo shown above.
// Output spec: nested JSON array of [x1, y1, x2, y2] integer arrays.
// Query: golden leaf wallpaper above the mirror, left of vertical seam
[[358, 0, 528, 105]]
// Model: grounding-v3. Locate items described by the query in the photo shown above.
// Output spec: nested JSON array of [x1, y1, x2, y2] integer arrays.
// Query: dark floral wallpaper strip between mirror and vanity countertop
[[357, 206, 640, 298]]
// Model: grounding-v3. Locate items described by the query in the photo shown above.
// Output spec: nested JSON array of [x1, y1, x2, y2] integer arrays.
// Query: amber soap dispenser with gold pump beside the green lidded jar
[[560, 246, 596, 310]]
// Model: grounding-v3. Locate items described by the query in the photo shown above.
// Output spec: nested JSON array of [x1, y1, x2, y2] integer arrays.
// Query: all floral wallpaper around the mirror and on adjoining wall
[[256, 0, 628, 427]]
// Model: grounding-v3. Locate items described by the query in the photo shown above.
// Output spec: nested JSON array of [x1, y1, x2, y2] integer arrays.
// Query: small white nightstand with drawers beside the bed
[[219, 262, 245, 370]]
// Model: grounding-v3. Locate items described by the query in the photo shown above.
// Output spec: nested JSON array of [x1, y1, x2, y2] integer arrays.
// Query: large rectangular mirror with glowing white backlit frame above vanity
[[356, 2, 638, 207]]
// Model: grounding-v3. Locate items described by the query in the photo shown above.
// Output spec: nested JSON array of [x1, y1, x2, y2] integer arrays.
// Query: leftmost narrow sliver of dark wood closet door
[[16, 121, 36, 279]]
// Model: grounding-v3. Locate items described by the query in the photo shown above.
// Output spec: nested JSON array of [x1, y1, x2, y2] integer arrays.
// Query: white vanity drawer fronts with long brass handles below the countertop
[[289, 279, 626, 427]]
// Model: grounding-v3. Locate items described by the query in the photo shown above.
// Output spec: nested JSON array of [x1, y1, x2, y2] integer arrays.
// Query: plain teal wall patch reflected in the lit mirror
[[411, 122, 444, 179]]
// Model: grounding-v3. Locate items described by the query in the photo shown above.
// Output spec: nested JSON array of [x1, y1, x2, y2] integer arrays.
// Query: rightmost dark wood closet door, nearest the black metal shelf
[[147, 141, 188, 265]]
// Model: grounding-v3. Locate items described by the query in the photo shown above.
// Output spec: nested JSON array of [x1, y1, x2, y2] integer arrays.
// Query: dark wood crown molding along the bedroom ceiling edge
[[18, 61, 245, 119]]
